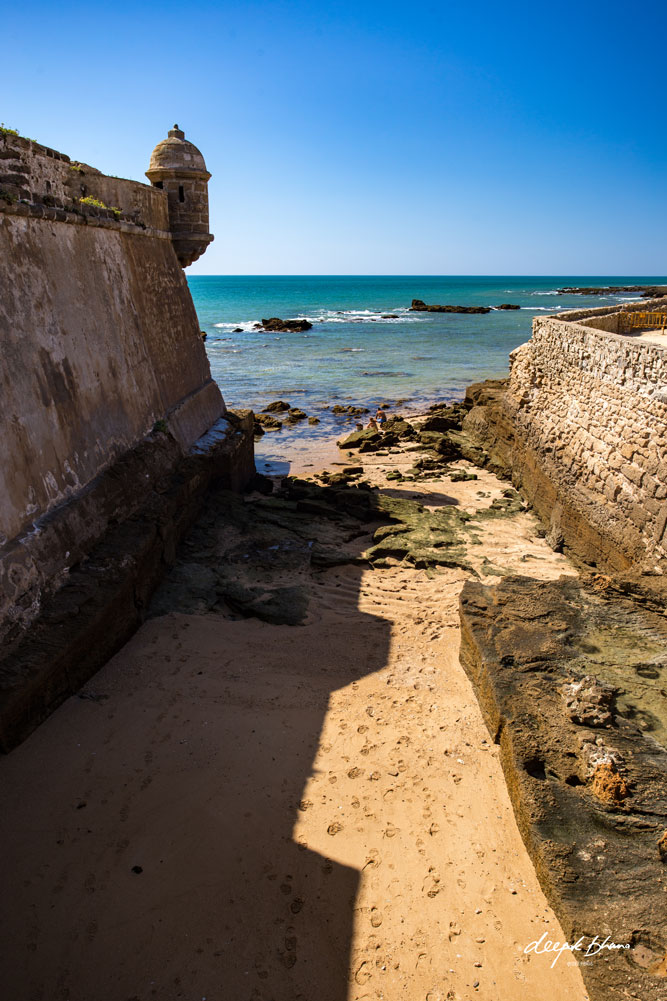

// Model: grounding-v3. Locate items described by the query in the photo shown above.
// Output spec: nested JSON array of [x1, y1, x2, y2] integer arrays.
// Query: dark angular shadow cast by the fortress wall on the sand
[[0, 516, 390, 1001]]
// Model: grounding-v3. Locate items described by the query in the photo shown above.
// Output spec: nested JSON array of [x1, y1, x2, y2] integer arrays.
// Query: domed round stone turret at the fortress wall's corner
[[146, 125, 213, 267]]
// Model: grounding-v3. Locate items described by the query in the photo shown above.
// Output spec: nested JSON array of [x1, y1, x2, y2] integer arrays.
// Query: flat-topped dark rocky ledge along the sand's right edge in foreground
[[461, 576, 667, 1001]]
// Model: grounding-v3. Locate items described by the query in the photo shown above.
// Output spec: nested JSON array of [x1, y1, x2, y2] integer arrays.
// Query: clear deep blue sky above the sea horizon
[[6, 0, 667, 275]]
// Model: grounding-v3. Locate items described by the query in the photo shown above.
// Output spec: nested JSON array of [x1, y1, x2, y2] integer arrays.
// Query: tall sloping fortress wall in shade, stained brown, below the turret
[[0, 131, 253, 742]]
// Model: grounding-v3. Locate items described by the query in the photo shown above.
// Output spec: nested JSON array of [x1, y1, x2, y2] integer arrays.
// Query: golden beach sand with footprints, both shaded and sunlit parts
[[0, 444, 586, 1001]]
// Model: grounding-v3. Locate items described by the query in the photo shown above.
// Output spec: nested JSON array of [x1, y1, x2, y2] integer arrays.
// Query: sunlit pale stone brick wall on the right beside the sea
[[503, 300, 667, 570]]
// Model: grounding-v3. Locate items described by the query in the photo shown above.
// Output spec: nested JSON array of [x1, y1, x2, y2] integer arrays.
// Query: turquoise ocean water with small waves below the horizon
[[188, 275, 667, 471]]
